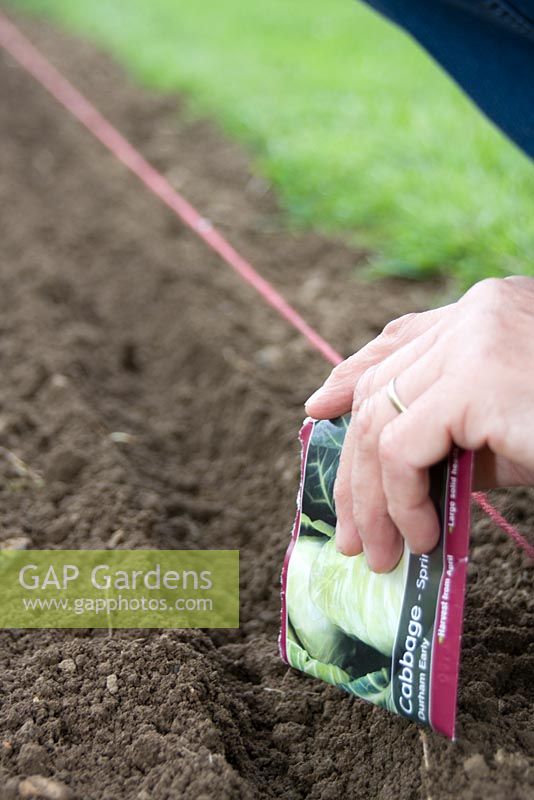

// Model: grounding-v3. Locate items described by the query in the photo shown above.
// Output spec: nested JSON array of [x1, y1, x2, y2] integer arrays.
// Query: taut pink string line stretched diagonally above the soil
[[0, 13, 534, 559]]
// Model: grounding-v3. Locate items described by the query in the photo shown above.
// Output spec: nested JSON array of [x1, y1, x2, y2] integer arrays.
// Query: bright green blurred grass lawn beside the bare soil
[[12, 0, 534, 286]]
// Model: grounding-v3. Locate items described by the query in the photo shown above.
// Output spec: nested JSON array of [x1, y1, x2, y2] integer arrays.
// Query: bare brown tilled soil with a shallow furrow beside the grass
[[0, 10, 534, 800]]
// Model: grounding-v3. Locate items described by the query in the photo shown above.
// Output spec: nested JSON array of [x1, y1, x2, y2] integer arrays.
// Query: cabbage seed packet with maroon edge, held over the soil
[[280, 415, 473, 739]]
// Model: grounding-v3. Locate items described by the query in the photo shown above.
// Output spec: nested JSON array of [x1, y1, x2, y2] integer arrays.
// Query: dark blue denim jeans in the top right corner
[[364, 0, 534, 158]]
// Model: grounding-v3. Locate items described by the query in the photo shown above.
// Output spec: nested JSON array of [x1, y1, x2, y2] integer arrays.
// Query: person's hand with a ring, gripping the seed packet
[[306, 277, 534, 572]]
